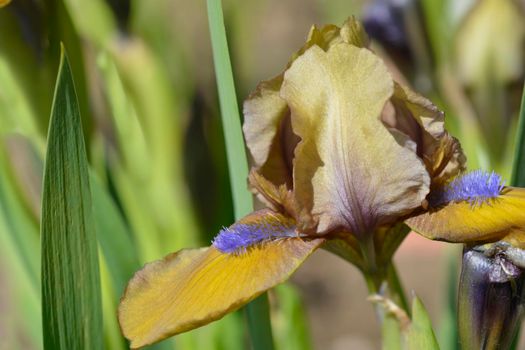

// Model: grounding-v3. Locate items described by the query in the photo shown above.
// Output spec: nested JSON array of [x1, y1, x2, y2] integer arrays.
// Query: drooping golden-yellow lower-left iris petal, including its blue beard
[[119, 210, 324, 348]]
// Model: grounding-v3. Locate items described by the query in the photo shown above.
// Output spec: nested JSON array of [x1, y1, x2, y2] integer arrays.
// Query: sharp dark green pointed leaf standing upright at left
[[41, 48, 102, 349]]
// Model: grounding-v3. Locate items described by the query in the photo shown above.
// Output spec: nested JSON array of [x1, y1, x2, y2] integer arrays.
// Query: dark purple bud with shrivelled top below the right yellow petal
[[458, 246, 525, 350]]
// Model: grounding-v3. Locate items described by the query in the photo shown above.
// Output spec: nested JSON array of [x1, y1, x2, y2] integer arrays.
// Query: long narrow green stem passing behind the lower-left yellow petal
[[207, 0, 274, 350]]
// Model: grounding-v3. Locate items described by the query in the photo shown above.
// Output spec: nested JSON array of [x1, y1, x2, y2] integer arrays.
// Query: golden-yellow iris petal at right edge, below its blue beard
[[405, 187, 525, 243]]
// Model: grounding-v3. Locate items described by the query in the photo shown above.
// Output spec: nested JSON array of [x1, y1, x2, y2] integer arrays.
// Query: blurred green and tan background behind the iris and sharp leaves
[[0, 0, 525, 350]]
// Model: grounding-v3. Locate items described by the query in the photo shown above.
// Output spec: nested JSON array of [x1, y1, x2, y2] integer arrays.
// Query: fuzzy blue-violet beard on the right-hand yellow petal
[[429, 170, 505, 207]]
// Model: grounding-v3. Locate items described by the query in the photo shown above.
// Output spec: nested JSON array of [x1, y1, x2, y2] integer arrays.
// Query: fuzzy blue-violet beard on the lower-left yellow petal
[[212, 220, 298, 253]]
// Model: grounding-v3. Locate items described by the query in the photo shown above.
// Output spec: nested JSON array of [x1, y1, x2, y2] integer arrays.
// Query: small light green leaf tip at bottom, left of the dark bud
[[407, 297, 439, 350]]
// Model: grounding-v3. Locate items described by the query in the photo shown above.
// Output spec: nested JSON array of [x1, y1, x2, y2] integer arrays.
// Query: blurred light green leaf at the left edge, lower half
[[0, 140, 42, 349]]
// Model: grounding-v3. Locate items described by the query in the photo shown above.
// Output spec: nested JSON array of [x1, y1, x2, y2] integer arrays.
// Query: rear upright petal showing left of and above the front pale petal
[[243, 17, 368, 188]]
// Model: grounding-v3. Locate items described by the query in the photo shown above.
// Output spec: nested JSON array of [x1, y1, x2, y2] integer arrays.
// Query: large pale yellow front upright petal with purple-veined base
[[281, 43, 430, 236]]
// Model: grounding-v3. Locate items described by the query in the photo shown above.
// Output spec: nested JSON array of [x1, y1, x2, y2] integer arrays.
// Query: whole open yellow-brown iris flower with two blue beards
[[119, 18, 525, 348]]
